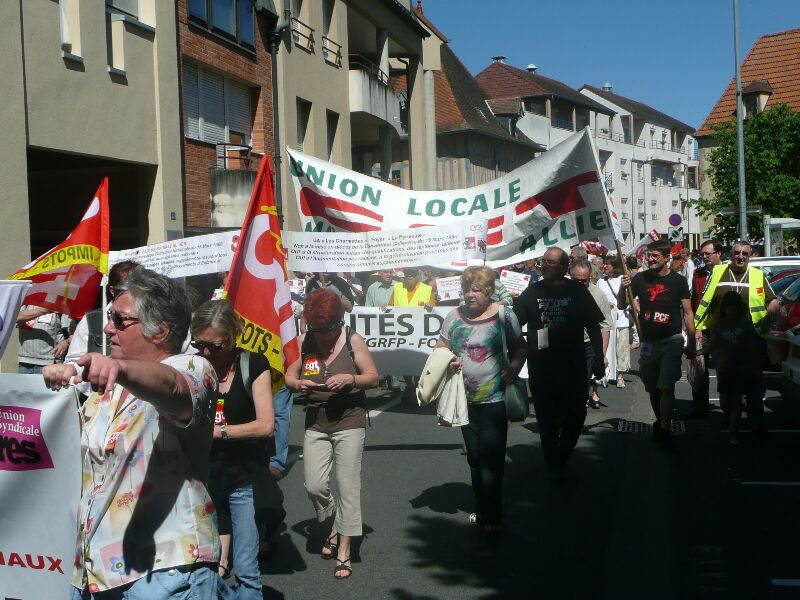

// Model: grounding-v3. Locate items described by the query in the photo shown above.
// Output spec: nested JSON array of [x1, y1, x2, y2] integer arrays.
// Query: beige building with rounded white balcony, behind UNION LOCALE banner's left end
[[275, 0, 439, 229]]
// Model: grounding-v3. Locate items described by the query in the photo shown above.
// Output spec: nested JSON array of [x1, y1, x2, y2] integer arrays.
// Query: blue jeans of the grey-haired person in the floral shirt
[[70, 565, 217, 600]]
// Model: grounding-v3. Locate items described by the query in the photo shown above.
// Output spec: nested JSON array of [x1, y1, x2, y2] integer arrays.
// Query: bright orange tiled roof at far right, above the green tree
[[695, 29, 800, 137]]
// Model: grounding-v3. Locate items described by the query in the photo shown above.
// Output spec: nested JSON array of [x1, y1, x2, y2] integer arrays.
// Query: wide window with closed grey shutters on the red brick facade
[[183, 63, 253, 146]]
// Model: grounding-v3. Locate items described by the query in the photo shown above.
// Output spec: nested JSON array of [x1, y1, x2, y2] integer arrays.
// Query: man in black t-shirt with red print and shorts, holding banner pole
[[617, 240, 694, 447]]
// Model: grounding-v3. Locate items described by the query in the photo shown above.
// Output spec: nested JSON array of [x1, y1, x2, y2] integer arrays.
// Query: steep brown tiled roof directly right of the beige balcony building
[[434, 44, 543, 149]]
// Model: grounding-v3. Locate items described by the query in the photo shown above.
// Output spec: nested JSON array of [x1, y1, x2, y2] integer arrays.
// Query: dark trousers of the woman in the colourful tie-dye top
[[461, 402, 508, 525]]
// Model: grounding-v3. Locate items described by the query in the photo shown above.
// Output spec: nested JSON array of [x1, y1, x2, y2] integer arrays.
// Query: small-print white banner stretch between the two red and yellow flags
[[108, 231, 239, 278]]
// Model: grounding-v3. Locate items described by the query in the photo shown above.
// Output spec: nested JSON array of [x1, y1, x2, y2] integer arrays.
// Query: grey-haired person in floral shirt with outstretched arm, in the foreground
[[43, 267, 220, 600]]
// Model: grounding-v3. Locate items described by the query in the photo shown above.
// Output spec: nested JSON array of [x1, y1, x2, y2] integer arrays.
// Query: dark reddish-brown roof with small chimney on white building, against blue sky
[[475, 62, 614, 115]]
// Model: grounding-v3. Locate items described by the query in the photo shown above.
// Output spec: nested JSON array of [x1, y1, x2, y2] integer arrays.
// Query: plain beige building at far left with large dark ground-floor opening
[[0, 0, 183, 370]]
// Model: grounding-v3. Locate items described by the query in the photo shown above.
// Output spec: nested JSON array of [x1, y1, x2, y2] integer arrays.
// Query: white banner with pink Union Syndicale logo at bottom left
[[0, 375, 81, 600]]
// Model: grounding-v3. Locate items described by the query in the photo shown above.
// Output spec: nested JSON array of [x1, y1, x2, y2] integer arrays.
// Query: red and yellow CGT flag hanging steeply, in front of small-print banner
[[224, 156, 300, 391]]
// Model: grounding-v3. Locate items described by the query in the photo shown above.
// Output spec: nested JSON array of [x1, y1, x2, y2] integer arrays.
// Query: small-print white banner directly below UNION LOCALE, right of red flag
[[282, 220, 487, 273]]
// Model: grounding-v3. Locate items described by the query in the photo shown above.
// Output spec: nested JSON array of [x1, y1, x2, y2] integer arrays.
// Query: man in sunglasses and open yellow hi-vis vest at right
[[695, 240, 779, 434]]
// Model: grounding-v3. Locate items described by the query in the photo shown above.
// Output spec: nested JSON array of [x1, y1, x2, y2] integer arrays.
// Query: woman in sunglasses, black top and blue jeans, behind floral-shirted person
[[192, 300, 275, 600]]
